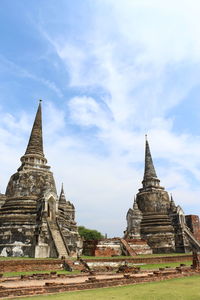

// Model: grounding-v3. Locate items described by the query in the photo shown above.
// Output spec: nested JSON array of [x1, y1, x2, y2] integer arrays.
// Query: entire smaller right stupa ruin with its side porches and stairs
[[124, 139, 200, 253]]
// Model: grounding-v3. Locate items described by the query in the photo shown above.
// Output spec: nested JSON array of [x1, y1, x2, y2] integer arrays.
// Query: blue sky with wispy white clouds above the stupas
[[0, 0, 200, 237]]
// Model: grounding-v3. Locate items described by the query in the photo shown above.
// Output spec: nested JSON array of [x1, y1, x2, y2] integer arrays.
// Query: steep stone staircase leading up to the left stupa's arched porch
[[48, 221, 69, 258]]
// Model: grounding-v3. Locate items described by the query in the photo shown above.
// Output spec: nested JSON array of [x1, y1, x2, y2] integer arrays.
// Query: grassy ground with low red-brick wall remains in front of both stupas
[[0, 253, 200, 300]]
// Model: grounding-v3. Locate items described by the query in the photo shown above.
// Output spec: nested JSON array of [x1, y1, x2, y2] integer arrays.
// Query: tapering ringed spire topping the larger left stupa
[[25, 100, 44, 157]]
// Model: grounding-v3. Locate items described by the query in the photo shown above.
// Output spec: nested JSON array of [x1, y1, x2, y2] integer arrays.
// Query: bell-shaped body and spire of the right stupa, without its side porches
[[126, 137, 175, 253]]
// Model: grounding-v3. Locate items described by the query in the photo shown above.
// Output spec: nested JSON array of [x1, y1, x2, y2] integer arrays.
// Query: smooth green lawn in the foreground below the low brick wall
[[10, 276, 200, 300]]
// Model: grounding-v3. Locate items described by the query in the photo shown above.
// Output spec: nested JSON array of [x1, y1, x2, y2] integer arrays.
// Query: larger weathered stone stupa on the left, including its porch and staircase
[[0, 102, 81, 257]]
